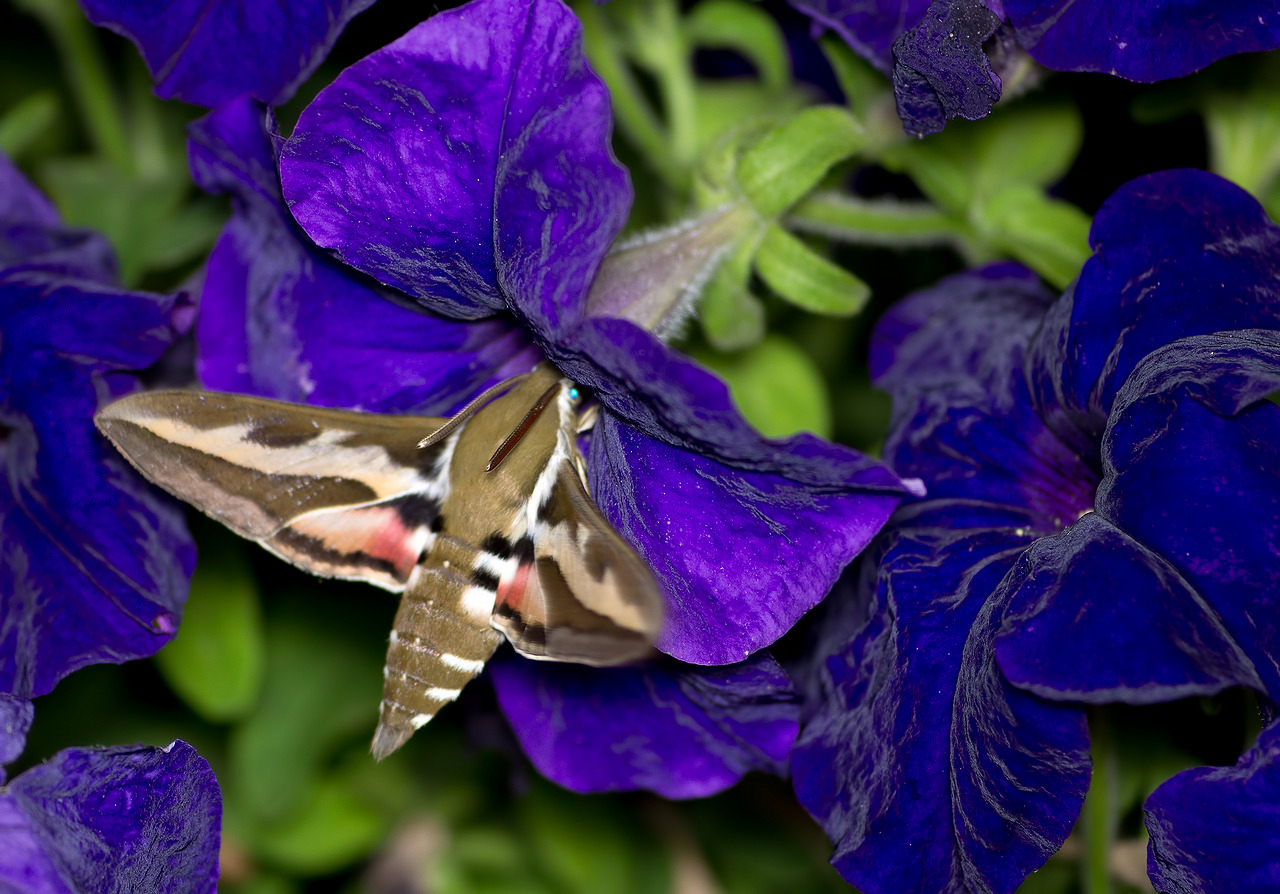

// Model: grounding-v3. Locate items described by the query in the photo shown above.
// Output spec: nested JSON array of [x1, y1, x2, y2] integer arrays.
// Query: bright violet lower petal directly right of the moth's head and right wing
[[589, 412, 899, 665]]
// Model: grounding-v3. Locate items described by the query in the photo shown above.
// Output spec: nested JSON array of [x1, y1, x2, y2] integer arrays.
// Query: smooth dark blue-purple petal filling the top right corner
[[1004, 0, 1280, 81]]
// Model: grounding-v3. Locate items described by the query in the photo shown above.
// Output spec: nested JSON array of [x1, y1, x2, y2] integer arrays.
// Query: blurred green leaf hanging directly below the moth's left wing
[[155, 532, 264, 722]]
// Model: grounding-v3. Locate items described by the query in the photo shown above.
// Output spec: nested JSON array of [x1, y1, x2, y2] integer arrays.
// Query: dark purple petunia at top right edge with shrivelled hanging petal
[[791, 0, 1280, 136]]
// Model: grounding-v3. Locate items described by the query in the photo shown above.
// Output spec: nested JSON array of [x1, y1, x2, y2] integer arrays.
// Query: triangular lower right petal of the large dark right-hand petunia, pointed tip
[[996, 512, 1262, 704]]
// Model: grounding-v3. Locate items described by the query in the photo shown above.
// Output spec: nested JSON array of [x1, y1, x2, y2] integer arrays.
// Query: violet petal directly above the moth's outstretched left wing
[[191, 100, 540, 414]]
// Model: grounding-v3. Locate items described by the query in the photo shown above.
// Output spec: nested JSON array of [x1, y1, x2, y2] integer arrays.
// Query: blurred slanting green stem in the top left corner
[[17, 0, 133, 172]]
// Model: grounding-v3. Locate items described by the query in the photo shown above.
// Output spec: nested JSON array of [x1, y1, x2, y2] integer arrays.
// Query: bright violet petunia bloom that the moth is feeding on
[[192, 0, 904, 797]]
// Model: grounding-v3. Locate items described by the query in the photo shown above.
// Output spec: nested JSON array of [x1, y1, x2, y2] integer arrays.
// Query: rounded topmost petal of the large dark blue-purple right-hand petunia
[[1032, 170, 1280, 438]]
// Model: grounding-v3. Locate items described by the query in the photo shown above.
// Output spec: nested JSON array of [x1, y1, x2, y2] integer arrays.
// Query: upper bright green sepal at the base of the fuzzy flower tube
[[737, 105, 867, 218]]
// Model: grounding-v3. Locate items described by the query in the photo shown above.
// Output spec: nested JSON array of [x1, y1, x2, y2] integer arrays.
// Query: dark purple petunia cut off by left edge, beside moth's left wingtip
[[0, 151, 196, 697]]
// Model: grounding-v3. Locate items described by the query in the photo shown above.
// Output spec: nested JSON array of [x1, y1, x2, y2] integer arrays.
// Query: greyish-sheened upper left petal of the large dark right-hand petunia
[[870, 264, 1098, 533]]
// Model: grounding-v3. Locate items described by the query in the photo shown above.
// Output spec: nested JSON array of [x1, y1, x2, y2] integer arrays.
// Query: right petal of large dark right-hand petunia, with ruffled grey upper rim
[[1097, 330, 1280, 697]]
